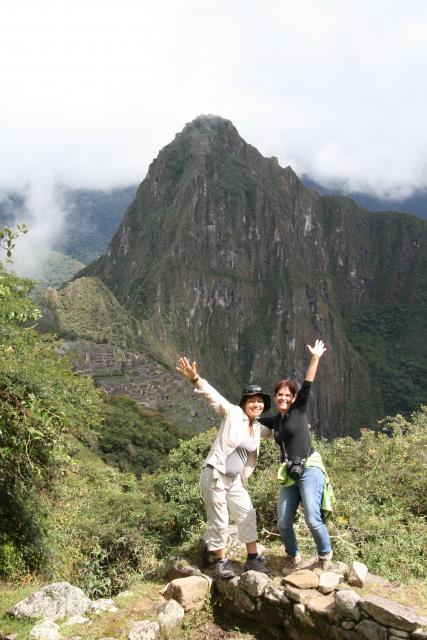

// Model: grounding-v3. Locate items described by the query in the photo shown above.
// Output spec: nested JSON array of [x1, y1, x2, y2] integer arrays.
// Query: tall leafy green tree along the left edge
[[0, 228, 100, 573]]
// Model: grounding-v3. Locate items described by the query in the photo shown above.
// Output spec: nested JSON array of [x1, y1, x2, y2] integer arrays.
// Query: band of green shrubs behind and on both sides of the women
[[55, 408, 427, 593]]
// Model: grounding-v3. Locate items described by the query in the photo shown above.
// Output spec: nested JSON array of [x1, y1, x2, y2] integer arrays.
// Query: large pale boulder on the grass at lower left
[[9, 582, 91, 620]]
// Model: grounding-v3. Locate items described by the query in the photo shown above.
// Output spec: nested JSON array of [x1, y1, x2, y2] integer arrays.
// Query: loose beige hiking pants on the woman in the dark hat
[[200, 466, 258, 551]]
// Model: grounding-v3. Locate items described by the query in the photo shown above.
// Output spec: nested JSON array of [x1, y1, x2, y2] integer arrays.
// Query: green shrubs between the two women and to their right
[[250, 407, 427, 581]]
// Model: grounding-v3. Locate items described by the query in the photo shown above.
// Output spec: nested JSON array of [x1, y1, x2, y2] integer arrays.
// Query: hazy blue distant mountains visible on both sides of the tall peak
[[0, 164, 427, 286]]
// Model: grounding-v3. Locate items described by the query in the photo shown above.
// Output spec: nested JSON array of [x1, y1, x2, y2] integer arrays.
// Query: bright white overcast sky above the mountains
[[0, 0, 427, 262]]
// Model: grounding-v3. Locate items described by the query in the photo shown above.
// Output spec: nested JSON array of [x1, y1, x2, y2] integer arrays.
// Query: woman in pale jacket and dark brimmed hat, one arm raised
[[176, 356, 272, 579]]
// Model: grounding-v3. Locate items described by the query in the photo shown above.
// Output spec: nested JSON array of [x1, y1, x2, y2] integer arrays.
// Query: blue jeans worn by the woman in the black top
[[277, 467, 332, 557]]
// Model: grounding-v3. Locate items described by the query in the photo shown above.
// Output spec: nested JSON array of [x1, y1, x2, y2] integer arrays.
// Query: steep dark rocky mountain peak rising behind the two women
[[85, 116, 426, 435]]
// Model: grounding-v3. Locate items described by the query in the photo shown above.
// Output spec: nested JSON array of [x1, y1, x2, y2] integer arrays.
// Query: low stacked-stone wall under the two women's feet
[[164, 561, 427, 640]]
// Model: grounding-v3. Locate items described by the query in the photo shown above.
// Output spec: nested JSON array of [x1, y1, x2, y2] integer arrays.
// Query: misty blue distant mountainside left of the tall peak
[[0, 185, 136, 287]]
